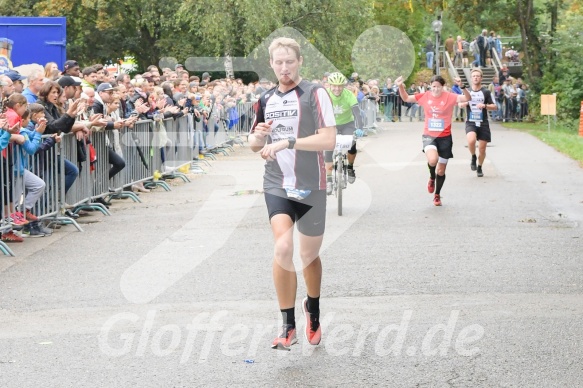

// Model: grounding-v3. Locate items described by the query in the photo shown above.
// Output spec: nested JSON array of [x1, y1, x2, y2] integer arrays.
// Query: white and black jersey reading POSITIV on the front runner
[[251, 80, 336, 190]]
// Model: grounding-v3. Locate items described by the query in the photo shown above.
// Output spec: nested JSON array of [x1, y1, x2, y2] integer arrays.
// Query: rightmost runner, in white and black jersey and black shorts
[[459, 68, 498, 177]]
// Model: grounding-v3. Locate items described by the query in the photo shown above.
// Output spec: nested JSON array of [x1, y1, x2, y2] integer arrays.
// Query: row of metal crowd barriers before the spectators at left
[[0, 111, 242, 256]]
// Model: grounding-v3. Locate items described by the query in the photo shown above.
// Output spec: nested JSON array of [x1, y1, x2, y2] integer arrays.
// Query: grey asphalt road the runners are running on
[[0, 119, 583, 387]]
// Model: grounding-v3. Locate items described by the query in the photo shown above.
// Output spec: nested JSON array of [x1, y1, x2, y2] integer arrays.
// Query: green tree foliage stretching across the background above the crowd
[[0, 0, 583, 121]]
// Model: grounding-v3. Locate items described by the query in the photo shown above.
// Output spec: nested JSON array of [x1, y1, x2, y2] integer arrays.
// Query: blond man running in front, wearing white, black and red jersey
[[249, 38, 336, 350]]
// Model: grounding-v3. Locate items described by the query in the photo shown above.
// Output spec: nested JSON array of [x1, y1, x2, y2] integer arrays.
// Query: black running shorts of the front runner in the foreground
[[265, 189, 326, 237]]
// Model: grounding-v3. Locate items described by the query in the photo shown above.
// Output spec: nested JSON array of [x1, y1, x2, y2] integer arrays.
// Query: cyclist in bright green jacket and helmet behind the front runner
[[324, 72, 363, 195]]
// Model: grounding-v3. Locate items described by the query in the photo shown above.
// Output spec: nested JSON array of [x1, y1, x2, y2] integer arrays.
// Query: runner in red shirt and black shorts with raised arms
[[395, 75, 471, 206]]
